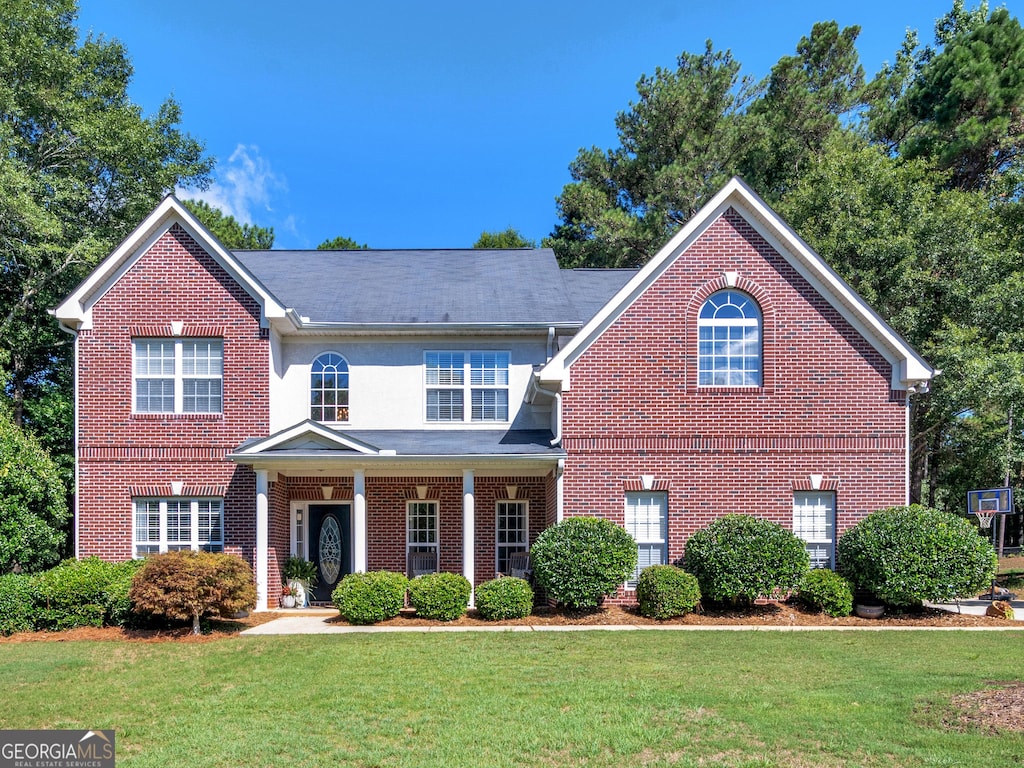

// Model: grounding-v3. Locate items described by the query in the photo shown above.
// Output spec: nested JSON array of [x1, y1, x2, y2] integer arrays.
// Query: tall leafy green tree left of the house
[[0, 0, 211, 433]]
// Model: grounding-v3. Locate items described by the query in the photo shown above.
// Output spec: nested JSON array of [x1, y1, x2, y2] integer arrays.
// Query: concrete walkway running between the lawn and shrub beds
[[242, 600, 1024, 635]]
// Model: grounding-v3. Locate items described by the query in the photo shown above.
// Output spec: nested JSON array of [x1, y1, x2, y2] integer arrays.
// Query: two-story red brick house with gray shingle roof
[[55, 179, 934, 607]]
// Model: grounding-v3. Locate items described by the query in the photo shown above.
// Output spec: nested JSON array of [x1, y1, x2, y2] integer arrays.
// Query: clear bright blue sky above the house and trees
[[79, 0, 1007, 248]]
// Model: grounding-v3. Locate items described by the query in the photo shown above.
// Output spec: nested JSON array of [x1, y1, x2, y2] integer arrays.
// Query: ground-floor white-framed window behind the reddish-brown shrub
[[134, 498, 224, 557]]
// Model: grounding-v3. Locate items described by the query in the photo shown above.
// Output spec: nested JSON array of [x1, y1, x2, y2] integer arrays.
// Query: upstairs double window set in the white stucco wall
[[424, 351, 510, 422]]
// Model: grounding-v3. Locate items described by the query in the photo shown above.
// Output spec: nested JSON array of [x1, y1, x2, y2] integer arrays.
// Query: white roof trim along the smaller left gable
[[51, 195, 286, 331]]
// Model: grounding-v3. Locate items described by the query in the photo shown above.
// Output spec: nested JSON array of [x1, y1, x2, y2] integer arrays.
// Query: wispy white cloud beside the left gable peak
[[178, 144, 288, 226]]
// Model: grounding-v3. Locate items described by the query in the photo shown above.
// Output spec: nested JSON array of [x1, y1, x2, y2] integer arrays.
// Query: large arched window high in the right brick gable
[[697, 291, 761, 387]]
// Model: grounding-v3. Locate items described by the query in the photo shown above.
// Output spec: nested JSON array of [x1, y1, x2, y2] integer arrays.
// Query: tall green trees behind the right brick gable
[[545, 6, 1024, 509]]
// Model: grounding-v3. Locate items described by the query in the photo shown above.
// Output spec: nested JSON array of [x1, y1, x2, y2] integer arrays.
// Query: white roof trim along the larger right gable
[[538, 177, 936, 390]]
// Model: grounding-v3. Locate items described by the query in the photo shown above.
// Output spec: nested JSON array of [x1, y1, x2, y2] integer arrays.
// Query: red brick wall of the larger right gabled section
[[562, 209, 906, 602]]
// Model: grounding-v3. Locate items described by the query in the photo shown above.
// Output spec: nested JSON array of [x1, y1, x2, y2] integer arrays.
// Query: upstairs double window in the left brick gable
[[132, 339, 224, 414]]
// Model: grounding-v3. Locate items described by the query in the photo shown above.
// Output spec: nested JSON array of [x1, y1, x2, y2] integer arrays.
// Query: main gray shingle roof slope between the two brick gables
[[234, 248, 585, 325]]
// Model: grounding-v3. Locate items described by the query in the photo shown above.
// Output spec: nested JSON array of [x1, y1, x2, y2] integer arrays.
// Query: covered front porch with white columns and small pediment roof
[[229, 422, 564, 609]]
